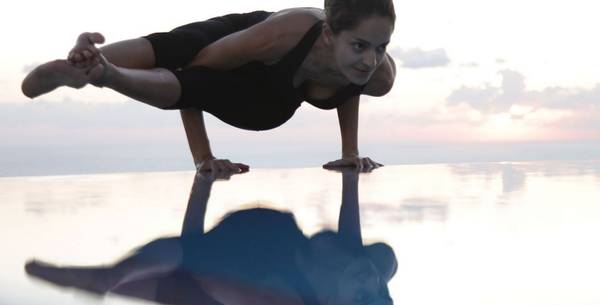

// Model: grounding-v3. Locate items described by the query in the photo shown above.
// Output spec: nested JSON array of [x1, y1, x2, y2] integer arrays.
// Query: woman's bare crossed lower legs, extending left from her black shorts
[[22, 38, 181, 108]]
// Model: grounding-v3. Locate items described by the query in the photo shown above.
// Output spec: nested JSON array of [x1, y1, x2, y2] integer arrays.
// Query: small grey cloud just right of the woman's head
[[390, 48, 450, 69]]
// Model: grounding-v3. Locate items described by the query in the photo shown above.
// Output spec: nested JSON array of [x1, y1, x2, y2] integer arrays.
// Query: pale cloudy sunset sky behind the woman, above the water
[[0, 0, 600, 175]]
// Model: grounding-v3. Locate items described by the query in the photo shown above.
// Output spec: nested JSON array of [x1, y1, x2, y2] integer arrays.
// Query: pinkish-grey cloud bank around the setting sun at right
[[440, 70, 600, 140]]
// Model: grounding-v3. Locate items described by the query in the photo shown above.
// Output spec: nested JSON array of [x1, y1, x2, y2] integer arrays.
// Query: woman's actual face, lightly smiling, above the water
[[331, 15, 394, 85]]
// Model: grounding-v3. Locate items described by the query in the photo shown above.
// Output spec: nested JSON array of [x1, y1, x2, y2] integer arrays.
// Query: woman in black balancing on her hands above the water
[[22, 0, 395, 171]]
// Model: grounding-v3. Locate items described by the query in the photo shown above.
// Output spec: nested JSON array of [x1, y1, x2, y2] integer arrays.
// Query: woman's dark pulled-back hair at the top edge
[[325, 0, 396, 34]]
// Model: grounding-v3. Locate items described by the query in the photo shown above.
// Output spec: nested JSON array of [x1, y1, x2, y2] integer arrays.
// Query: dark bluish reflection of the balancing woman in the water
[[26, 172, 396, 305]]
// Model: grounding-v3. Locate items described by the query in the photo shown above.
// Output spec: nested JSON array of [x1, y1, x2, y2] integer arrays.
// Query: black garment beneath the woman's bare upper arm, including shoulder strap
[[167, 20, 365, 130]]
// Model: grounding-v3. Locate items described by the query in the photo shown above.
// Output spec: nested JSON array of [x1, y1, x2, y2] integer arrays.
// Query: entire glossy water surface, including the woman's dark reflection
[[0, 161, 600, 304]]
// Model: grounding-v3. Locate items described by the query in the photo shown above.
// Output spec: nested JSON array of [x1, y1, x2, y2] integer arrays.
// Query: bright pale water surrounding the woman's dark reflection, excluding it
[[0, 161, 600, 305]]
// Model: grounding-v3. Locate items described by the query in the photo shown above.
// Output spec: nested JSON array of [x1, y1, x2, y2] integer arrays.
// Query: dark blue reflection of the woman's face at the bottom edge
[[329, 258, 389, 305]]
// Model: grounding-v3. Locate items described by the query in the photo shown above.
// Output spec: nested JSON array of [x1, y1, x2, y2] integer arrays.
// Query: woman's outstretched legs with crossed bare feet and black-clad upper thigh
[[22, 11, 270, 108]]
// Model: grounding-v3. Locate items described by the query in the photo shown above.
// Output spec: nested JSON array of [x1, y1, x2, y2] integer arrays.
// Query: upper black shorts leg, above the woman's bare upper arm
[[143, 11, 272, 70]]
